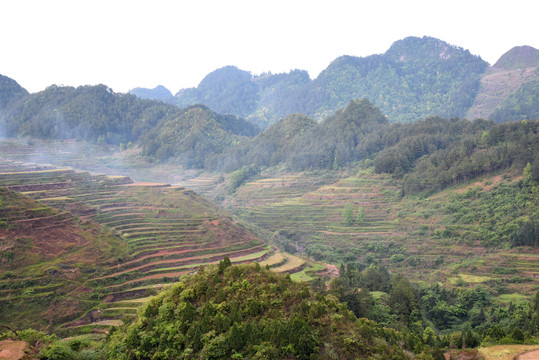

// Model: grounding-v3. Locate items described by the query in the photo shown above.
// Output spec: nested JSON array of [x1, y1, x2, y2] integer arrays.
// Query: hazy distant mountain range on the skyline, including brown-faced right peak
[[131, 37, 539, 129]]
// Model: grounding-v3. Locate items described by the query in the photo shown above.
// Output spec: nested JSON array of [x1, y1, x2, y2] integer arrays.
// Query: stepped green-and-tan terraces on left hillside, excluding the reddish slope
[[0, 161, 320, 332]]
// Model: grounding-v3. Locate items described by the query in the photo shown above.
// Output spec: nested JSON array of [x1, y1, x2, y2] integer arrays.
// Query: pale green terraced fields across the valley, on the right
[[202, 171, 539, 294]]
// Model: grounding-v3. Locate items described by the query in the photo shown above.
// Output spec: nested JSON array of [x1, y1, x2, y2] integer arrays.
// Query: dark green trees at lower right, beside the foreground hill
[[330, 264, 539, 348]]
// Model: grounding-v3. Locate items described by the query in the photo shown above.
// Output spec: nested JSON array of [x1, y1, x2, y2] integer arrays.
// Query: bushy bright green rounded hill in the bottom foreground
[[107, 261, 407, 359]]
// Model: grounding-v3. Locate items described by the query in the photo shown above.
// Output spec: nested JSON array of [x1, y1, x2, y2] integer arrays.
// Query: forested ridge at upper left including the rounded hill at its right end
[[0, 80, 258, 163]]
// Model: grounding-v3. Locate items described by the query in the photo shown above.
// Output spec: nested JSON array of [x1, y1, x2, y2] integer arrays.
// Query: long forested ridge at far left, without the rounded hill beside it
[[0, 85, 179, 144]]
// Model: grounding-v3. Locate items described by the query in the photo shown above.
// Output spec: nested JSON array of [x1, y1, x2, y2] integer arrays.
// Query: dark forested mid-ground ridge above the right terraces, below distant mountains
[[206, 99, 539, 194]]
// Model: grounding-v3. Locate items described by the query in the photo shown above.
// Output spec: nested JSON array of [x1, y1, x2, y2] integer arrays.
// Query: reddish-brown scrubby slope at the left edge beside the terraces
[[0, 172, 127, 330]]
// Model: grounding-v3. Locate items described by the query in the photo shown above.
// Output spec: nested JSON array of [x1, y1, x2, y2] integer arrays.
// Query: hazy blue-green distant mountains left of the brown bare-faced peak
[[172, 37, 487, 128]]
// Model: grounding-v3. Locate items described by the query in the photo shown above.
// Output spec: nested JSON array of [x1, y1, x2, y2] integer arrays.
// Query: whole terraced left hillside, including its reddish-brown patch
[[0, 161, 316, 334]]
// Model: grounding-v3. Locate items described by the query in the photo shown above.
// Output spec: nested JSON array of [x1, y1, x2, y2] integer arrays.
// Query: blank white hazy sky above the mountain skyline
[[0, 0, 539, 93]]
